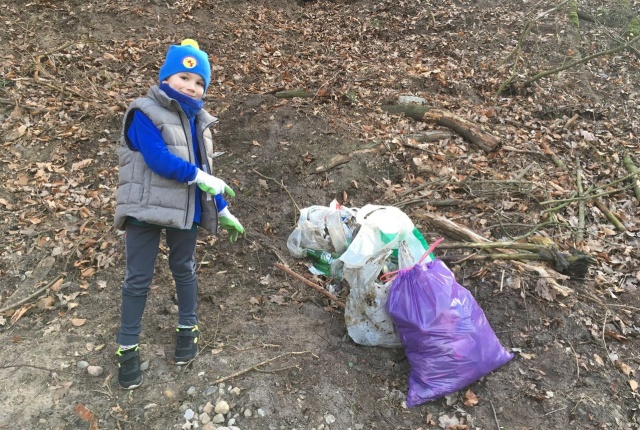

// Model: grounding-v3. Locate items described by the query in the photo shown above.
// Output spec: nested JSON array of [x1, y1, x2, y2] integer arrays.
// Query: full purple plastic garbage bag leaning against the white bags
[[386, 260, 513, 407]]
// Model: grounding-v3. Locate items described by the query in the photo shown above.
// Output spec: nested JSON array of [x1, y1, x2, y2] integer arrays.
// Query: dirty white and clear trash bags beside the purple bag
[[287, 200, 432, 348]]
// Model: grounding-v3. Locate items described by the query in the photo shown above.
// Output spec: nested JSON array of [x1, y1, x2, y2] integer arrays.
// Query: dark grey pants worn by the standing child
[[118, 223, 198, 345]]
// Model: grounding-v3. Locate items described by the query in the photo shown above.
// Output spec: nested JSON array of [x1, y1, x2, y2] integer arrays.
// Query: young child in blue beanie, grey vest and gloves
[[115, 39, 244, 389]]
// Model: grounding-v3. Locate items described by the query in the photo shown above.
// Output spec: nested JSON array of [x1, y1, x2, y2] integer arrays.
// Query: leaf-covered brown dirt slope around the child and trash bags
[[0, 1, 640, 429]]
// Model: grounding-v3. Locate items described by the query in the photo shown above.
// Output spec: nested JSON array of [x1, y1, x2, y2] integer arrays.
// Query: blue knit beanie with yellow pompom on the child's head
[[160, 39, 211, 91]]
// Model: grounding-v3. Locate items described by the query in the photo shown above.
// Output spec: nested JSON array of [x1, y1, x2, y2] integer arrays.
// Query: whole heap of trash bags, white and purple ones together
[[287, 200, 513, 407]]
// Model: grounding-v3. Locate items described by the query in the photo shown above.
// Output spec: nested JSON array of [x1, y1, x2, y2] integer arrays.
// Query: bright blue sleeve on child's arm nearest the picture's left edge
[[127, 111, 197, 182]]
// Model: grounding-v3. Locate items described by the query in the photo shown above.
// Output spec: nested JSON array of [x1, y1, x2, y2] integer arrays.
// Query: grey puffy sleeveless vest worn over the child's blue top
[[114, 85, 218, 233]]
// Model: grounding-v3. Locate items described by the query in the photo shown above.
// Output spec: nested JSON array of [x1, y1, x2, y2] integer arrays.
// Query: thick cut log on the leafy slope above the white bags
[[382, 105, 500, 152]]
